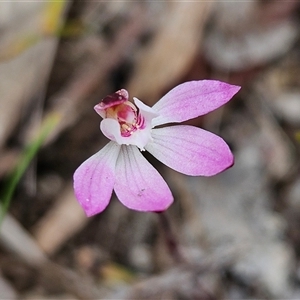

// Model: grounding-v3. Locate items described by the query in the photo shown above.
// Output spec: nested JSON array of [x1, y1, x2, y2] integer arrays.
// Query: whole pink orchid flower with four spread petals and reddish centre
[[74, 80, 240, 216]]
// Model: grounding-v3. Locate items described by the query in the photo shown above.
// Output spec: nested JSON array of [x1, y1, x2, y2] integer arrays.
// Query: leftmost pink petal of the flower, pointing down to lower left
[[74, 142, 121, 217]]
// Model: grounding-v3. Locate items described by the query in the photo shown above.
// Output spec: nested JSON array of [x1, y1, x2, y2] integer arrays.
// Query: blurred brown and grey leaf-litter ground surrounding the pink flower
[[0, 0, 300, 299]]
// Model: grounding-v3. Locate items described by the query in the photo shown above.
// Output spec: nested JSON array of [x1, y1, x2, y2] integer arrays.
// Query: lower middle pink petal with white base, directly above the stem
[[115, 146, 173, 211]]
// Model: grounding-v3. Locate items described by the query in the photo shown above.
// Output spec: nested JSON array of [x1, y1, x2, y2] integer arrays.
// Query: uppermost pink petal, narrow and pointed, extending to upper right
[[152, 80, 240, 127]]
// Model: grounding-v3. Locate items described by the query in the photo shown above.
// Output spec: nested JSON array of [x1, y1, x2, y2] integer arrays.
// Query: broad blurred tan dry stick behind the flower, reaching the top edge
[[127, 1, 214, 105]]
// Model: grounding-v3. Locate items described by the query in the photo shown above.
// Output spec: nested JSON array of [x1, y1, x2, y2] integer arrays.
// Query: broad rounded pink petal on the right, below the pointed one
[[145, 125, 233, 176]]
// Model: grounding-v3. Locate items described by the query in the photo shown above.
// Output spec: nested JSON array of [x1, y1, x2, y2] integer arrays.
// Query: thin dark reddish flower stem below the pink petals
[[157, 212, 185, 263]]
